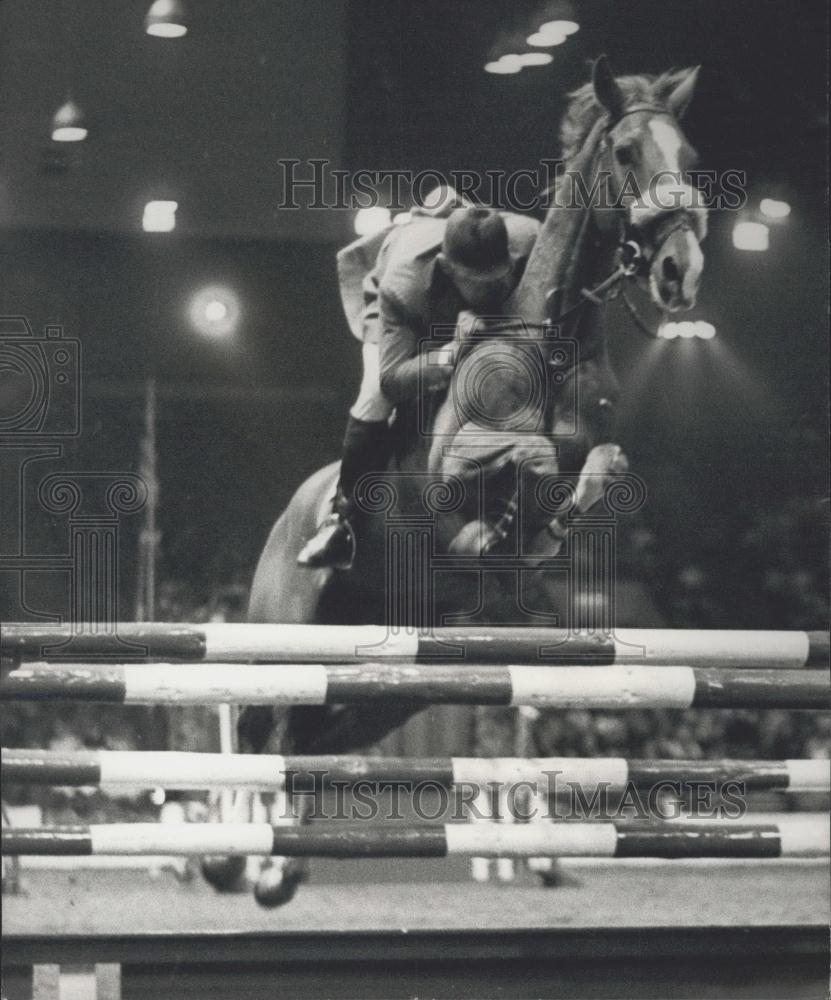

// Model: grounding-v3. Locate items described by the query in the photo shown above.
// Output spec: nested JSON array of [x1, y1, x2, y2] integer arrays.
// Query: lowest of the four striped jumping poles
[[3, 817, 829, 858]]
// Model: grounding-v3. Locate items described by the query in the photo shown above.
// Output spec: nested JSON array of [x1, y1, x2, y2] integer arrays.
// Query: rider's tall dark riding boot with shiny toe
[[297, 416, 391, 569]]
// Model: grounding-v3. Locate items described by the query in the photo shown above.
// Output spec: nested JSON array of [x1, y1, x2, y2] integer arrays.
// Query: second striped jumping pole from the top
[[0, 662, 831, 709]]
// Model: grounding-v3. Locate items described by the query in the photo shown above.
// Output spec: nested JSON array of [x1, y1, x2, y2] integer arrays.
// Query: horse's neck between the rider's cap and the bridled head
[[510, 119, 605, 326]]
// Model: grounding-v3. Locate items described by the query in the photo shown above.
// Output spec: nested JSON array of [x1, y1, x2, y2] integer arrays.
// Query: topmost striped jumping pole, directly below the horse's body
[[0, 622, 829, 669]]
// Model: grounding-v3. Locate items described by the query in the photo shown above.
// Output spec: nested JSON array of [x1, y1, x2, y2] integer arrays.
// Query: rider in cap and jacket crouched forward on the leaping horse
[[297, 197, 539, 568]]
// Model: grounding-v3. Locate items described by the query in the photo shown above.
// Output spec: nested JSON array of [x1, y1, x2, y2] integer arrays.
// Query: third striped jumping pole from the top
[[0, 748, 831, 793]]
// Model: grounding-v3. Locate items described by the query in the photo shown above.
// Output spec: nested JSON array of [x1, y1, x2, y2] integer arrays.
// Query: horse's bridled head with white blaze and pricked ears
[[592, 56, 707, 312]]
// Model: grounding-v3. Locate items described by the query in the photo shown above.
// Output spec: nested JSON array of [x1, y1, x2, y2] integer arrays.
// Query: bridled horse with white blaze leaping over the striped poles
[[205, 56, 706, 905]]
